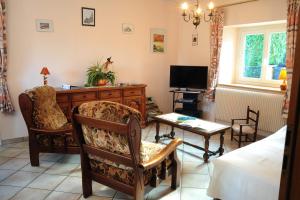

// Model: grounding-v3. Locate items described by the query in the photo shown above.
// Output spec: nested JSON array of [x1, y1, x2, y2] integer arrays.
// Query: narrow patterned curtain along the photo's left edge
[[0, 0, 14, 112]]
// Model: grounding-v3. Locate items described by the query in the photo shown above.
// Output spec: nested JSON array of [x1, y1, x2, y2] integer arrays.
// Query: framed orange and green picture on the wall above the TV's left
[[150, 29, 167, 53]]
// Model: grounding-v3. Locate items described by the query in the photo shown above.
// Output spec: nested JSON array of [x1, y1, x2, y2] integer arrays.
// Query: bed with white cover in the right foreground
[[207, 127, 286, 200]]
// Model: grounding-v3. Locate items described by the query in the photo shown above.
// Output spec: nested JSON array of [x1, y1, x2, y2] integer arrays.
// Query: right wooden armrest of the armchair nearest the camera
[[139, 138, 183, 170]]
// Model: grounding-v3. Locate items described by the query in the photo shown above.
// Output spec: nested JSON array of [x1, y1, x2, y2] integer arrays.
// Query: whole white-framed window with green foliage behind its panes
[[236, 24, 286, 87]]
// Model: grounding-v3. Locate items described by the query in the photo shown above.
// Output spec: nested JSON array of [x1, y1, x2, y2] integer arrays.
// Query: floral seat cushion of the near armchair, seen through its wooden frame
[[89, 141, 171, 185]]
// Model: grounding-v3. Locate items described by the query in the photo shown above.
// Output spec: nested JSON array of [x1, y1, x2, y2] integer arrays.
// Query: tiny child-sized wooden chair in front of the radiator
[[231, 106, 259, 147]]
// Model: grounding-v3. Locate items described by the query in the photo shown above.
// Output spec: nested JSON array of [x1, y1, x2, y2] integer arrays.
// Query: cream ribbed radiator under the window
[[215, 87, 285, 132]]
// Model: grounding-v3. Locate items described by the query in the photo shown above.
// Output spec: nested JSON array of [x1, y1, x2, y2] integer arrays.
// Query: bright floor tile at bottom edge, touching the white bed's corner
[[181, 188, 213, 200]]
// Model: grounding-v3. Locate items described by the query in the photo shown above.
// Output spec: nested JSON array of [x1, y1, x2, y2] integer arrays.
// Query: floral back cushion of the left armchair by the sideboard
[[26, 85, 68, 130]]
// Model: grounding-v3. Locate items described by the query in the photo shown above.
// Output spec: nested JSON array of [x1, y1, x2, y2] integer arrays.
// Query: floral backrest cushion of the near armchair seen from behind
[[78, 101, 141, 155]]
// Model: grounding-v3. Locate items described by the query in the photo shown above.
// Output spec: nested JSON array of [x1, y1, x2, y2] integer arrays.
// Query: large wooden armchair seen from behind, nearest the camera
[[72, 101, 182, 199]]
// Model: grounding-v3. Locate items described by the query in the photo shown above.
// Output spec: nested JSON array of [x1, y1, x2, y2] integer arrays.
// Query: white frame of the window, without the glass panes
[[234, 23, 286, 87]]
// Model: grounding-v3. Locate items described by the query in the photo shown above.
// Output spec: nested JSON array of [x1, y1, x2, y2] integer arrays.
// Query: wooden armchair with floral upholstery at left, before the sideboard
[[19, 86, 80, 166]]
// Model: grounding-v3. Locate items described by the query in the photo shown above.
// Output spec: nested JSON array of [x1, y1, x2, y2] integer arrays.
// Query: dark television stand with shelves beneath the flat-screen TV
[[170, 89, 205, 118]]
